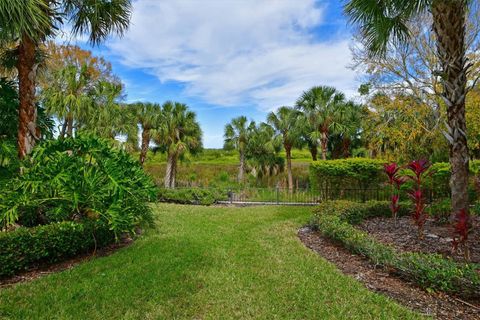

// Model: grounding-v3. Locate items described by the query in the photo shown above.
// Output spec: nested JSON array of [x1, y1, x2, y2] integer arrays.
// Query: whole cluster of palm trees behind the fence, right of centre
[[224, 86, 365, 190]]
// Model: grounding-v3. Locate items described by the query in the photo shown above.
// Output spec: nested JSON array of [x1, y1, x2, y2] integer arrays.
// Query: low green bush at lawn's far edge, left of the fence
[[158, 188, 227, 206]]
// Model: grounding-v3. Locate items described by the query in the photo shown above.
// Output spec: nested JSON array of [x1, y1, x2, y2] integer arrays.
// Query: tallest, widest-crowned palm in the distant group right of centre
[[296, 86, 345, 160]]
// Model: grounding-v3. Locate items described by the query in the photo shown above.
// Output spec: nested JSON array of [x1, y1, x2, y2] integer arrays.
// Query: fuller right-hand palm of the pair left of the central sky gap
[[154, 101, 202, 188]]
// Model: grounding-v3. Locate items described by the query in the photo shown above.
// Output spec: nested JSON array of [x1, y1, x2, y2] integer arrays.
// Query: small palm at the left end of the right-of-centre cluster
[[224, 116, 251, 183]]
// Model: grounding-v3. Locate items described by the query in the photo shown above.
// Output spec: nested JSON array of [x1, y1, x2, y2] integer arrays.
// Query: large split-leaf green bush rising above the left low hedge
[[0, 136, 156, 236]]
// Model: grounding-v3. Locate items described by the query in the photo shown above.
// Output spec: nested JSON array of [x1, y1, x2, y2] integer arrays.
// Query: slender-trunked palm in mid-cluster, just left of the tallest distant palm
[[267, 107, 302, 192]]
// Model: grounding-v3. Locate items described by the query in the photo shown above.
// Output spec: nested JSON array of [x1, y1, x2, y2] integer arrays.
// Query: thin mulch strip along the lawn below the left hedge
[[0, 238, 133, 288]]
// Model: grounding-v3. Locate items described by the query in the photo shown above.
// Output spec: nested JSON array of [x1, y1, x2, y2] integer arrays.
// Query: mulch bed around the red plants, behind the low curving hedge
[[357, 216, 480, 263]]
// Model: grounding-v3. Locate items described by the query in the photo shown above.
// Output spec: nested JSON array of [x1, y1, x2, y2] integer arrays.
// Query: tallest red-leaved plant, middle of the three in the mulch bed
[[407, 160, 430, 239]]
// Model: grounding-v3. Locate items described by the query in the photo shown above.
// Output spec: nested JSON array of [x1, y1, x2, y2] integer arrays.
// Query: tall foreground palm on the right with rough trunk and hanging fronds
[[345, 0, 471, 212]]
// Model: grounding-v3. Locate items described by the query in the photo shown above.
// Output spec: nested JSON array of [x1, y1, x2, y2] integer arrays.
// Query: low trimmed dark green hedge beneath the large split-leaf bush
[[0, 221, 115, 278]]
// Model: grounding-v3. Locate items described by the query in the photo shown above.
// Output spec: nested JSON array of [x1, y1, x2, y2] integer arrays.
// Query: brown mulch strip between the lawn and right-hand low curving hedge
[[298, 228, 480, 319]]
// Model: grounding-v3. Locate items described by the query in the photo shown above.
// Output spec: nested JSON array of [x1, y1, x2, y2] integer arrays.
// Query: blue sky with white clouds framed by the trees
[[73, 0, 359, 148]]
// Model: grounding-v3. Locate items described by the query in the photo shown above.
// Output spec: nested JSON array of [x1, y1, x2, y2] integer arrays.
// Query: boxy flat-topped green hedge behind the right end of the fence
[[310, 158, 386, 190]]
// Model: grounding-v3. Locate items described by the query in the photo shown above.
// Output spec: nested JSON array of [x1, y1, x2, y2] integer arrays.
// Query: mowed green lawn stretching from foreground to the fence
[[0, 204, 419, 319]]
